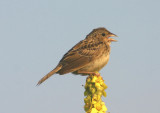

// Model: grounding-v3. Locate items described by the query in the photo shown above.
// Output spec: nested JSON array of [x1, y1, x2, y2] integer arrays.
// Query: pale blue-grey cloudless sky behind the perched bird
[[0, 0, 160, 113]]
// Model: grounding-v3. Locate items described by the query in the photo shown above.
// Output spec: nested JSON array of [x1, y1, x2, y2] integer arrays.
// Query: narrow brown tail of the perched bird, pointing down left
[[37, 65, 62, 85]]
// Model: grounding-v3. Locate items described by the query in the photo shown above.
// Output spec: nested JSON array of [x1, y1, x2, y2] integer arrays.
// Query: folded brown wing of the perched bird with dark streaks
[[58, 40, 103, 74]]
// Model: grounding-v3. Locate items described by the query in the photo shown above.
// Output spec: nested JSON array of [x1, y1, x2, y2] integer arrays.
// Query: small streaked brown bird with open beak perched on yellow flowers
[[37, 27, 117, 85]]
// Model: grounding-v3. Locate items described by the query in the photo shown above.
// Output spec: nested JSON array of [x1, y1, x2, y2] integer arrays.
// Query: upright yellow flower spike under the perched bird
[[84, 75, 107, 113]]
